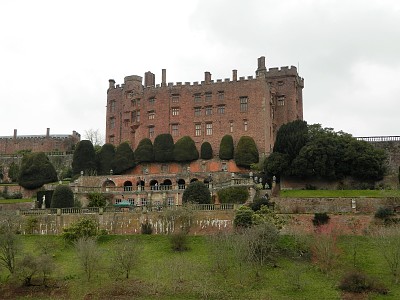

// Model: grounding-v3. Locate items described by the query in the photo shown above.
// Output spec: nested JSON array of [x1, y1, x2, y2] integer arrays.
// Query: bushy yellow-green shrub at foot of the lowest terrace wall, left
[[62, 218, 98, 242]]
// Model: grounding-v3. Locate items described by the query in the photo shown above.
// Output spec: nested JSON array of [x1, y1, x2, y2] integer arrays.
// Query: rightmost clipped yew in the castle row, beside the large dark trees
[[235, 136, 259, 168]]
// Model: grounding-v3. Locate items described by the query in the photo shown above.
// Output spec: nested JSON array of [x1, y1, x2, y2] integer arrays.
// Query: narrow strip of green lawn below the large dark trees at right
[[280, 190, 400, 198]]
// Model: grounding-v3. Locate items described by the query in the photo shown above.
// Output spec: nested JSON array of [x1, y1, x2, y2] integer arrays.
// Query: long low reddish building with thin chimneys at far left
[[0, 128, 81, 155]]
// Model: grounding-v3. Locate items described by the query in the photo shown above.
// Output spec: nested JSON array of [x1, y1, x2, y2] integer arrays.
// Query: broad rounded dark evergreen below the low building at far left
[[18, 152, 57, 189]]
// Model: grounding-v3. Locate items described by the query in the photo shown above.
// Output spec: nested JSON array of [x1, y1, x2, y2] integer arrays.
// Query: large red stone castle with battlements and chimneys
[[106, 57, 304, 155]]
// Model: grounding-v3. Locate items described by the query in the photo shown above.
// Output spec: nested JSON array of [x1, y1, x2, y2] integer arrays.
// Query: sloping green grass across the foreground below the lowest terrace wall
[[0, 235, 400, 300]]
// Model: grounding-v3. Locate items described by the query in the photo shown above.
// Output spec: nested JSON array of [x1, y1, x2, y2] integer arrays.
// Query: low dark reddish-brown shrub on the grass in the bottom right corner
[[339, 271, 388, 295]]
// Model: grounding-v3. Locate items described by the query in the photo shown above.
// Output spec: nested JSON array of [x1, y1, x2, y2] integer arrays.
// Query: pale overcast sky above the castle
[[0, 0, 400, 141]]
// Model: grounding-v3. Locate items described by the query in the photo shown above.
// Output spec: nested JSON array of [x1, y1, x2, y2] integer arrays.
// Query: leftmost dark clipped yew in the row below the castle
[[72, 140, 96, 175]]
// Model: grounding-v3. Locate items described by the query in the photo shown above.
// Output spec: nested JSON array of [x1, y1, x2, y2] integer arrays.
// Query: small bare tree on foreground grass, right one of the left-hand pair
[[111, 239, 141, 279]]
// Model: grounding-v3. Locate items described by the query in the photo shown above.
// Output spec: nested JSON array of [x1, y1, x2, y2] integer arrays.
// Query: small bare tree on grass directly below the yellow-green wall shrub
[[75, 237, 100, 281]]
